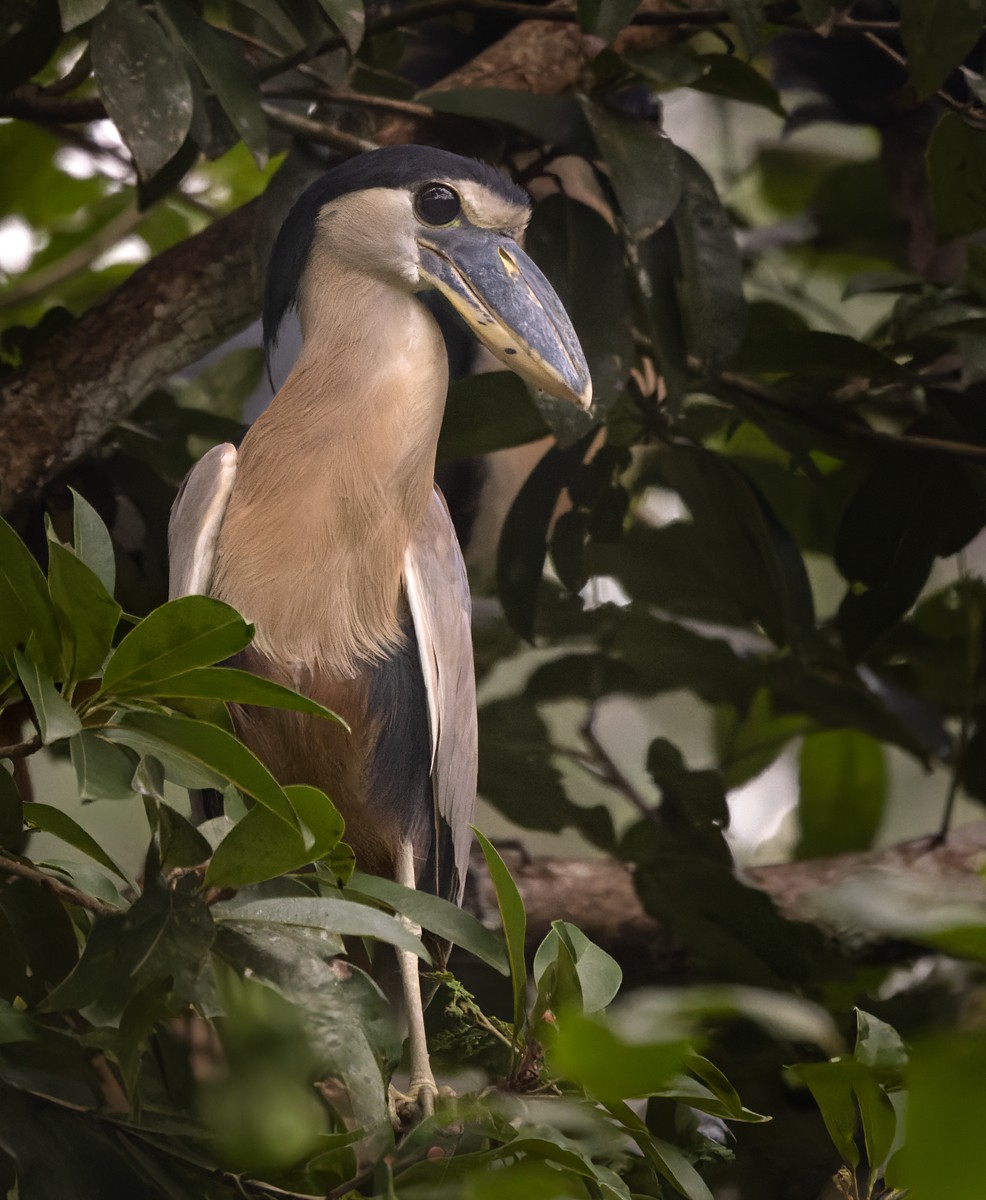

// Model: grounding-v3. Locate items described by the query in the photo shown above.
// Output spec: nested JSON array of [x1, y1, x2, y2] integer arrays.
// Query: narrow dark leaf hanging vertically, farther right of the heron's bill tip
[[674, 150, 746, 376]]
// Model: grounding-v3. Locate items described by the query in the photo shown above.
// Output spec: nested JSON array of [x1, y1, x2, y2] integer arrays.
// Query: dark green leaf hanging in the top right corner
[[900, 0, 986, 100]]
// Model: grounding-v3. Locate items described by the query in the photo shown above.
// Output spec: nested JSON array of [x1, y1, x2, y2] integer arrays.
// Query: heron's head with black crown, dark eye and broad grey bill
[[264, 146, 593, 407]]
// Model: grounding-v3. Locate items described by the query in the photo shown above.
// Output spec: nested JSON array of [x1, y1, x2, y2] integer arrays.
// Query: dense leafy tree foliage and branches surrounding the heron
[[0, 0, 986, 1200]]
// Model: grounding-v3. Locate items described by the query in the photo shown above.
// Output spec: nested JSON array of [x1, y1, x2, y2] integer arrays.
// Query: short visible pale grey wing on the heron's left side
[[168, 442, 236, 600]]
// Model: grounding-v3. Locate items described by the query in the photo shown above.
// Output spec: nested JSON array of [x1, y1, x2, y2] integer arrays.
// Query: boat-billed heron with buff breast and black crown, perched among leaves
[[169, 146, 591, 1114]]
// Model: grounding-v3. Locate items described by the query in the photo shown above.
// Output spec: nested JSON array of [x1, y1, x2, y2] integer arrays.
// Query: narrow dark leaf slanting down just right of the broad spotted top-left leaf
[[157, 0, 268, 167]]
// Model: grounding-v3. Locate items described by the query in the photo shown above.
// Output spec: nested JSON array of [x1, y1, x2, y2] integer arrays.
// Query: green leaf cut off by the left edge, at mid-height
[[0, 517, 61, 677]]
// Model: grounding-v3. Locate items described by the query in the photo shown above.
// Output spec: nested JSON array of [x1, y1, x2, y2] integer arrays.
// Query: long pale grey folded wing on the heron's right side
[[404, 490, 479, 904]]
